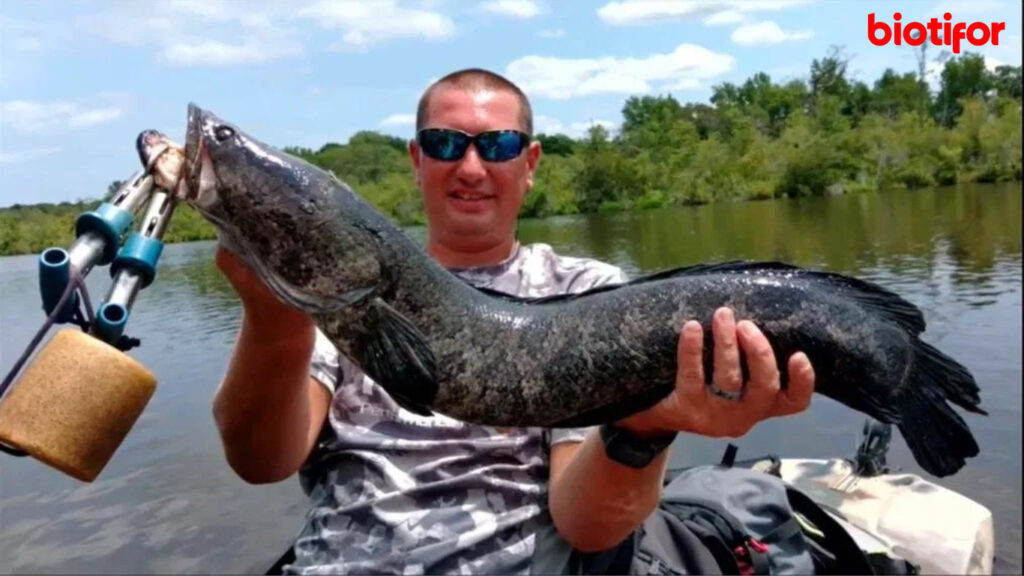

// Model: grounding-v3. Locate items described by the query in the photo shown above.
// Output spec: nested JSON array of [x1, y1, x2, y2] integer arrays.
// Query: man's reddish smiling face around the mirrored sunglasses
[[410, 86, 541, 250]]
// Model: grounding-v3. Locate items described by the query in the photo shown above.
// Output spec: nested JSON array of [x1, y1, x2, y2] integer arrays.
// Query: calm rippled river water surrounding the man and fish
[[0, 183, 1022, 573]]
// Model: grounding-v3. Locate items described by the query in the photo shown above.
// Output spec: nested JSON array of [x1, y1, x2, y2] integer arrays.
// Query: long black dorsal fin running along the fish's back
[[477, 260, 925, 334]]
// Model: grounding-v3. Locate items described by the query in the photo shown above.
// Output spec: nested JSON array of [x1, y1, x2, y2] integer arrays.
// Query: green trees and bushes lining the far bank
[[0, 51, 1021, 254]]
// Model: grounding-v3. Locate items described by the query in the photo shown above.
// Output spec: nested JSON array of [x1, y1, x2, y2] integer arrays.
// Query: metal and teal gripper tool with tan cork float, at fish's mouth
[[0, 140, 176, 482]]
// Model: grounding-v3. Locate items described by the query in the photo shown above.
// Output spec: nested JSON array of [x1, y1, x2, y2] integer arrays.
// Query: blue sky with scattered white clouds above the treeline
[[0, 0, 1022, 207]]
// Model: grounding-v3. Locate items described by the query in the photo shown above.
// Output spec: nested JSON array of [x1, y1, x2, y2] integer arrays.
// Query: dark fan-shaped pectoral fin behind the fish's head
[[357, 297, 437, 416]]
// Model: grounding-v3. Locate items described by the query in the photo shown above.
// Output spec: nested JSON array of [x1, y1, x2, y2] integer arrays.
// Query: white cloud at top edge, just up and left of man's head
[[296, 0, 455, 49]]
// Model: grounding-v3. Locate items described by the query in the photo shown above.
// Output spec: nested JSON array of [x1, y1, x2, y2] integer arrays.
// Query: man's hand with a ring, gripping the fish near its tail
[[618, 307, 814, 438]]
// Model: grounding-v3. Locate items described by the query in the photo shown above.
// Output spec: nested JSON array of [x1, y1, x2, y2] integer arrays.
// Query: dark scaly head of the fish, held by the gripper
[[183, 105, 380, 314]]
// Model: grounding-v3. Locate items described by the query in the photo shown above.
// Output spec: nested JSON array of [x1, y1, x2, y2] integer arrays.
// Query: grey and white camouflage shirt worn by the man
[[286, 239, 627, 574]]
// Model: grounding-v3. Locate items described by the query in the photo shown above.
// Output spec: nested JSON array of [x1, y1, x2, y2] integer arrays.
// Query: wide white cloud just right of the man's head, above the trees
[[505, 44, 734, 99]]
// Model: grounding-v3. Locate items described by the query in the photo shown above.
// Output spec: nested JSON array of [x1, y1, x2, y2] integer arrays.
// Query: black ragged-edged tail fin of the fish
[[898, 342, 986, 478]]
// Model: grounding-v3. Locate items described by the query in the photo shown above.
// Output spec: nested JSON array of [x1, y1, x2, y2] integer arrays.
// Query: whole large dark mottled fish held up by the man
[[159, 106, 984, 476]]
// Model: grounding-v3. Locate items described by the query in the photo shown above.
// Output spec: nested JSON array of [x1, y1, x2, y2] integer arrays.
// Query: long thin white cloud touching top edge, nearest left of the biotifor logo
[[597, 0, 808, 26]]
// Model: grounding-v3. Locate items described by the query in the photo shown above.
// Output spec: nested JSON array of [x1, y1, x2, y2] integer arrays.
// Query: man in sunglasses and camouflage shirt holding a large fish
[[214, 70, 814, 574]]
